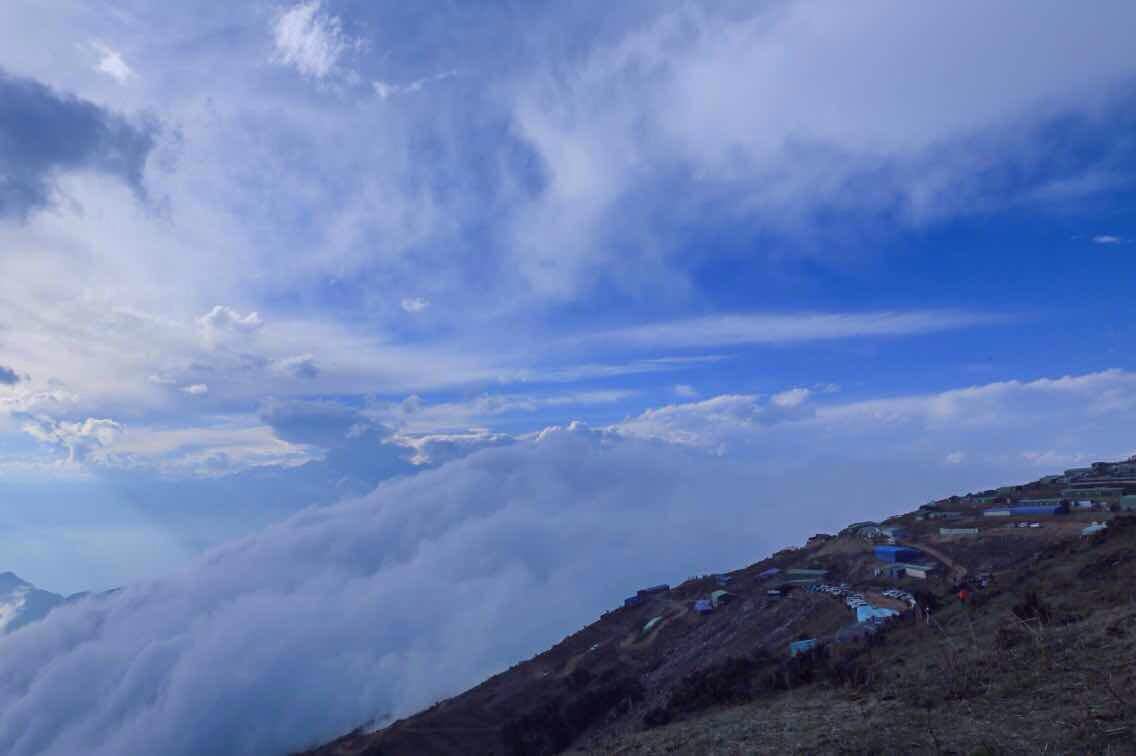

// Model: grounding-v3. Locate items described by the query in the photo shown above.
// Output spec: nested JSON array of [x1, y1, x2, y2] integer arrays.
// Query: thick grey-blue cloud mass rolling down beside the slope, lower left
[[0, 426, 845, 756]]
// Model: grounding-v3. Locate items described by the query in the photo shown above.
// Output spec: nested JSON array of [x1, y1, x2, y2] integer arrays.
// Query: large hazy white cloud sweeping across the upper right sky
[[512, 0, 1136, 297]]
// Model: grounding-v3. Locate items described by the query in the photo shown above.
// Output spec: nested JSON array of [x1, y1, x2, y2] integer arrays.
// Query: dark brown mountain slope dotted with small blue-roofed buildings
[[307, 460, 1136, 756]]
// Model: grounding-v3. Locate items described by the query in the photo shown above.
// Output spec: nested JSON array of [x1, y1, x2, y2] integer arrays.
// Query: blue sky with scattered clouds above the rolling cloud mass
[[0, 0, 1136, 590]]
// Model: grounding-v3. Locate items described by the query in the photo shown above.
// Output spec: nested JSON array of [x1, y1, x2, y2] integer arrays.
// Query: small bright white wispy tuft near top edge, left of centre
[[273, 0, 358, 78]]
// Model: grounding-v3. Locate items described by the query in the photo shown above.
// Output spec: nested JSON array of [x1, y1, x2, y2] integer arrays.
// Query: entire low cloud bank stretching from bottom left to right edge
[[0, 371, 1136, 756]]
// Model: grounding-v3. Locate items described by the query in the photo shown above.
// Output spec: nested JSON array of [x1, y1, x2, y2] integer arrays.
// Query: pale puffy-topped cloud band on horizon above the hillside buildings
[[611, 369, 1136, 472]]
